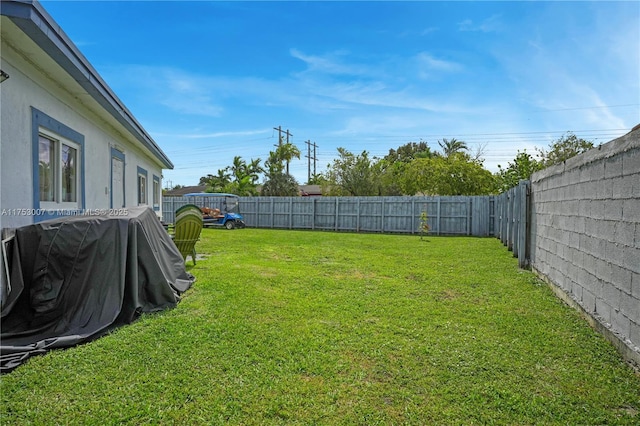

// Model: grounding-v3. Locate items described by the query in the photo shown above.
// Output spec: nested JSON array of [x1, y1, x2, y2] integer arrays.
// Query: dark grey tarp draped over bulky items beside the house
[[0, 208, 195, 373]]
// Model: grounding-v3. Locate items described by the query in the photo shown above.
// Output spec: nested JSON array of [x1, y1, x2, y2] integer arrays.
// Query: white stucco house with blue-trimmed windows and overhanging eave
[[0, 0, 173, 233]]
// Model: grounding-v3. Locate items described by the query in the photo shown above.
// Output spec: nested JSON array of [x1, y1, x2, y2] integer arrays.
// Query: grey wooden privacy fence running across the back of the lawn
[[163, 196, 499, 236]]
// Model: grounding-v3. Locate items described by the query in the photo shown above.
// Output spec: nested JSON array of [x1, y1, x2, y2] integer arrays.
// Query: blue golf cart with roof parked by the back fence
[[185, 192, 246, 229]]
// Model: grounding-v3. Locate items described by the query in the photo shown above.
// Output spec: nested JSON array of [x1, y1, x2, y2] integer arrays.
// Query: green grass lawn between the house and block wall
[[0, 229, 640, 425]]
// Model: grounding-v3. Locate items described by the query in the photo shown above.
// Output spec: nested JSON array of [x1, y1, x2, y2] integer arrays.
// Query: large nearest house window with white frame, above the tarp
[[38, 129, 81, 209]]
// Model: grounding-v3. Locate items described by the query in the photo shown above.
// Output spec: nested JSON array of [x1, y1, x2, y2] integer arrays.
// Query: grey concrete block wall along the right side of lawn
[[531, 128, 640, 364]]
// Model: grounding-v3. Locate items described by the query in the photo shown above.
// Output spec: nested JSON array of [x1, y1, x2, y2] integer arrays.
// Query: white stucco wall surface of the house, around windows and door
[[0, 19, 162, 228]]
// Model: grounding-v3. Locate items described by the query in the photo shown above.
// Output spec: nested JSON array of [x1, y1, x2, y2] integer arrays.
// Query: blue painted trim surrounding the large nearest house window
[[31, 107, 86, 222]]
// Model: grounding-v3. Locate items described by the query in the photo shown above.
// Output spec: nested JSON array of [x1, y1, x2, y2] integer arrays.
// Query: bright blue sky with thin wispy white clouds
[[42, 0, 640, 186]]
